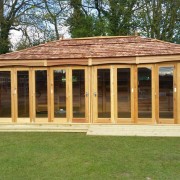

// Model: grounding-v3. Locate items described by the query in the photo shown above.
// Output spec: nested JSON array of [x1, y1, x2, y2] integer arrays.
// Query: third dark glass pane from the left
[[35, 70, 48, 117]]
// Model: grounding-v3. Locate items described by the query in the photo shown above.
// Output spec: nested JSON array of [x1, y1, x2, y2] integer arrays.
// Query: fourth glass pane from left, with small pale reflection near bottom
[[54, 70, 66, 118]]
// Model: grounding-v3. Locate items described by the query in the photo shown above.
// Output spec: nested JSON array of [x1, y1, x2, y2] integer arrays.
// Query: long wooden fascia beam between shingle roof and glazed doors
[[0, 55, 180, 67]]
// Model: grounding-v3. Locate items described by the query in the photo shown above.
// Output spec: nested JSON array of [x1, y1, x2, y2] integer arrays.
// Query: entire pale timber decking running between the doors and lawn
[[0, 123, 180, 137]]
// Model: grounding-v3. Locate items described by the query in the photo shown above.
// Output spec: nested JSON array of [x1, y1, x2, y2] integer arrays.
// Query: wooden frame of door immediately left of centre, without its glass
[[67, 66, 91, 124]]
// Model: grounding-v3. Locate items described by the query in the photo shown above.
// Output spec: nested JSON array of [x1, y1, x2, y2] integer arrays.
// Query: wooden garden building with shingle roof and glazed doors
[[0, 36, 180, 124]]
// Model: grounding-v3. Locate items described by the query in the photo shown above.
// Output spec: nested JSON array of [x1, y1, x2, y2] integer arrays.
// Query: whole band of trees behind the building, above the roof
[[0, 0, 180, 54]]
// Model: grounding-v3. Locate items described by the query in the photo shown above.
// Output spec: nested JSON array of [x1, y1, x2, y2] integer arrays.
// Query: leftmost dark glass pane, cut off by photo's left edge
[[0, 71, 11, 117]]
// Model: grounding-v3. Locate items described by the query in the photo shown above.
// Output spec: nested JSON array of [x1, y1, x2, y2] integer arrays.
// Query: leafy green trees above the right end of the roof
[[138, 0, 180, 42]]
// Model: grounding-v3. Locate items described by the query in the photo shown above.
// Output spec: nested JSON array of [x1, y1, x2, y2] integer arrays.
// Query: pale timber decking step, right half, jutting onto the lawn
[[87, 125, 180, 137]]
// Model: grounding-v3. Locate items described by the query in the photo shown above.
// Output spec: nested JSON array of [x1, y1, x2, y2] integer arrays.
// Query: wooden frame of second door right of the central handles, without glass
[[114, 65, 134, 124]]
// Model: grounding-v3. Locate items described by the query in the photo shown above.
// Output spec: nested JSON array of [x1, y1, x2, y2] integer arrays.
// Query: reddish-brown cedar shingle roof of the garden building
[[0, 36, 180, 60]]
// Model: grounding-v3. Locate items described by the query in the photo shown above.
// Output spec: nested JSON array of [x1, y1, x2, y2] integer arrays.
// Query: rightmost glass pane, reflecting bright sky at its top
[[159, 67, 174, 118]]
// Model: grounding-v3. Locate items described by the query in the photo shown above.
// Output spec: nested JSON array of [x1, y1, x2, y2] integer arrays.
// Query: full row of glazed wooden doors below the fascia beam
[[0, 62, 180, 124]]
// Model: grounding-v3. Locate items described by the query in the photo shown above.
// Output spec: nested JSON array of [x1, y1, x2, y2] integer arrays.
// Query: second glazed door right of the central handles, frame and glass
[[114, 66, 134, 123]]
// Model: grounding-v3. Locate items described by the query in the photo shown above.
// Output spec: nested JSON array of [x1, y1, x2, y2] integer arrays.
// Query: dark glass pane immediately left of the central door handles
[[72, 69, 85, 118]]
